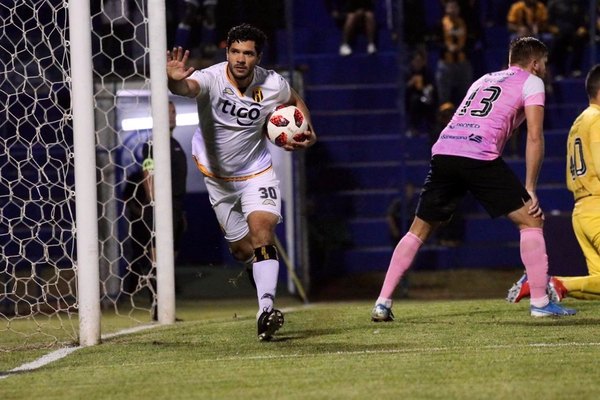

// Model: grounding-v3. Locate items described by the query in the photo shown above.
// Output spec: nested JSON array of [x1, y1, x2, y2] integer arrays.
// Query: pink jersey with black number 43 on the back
[[431, 66, 546, 160]]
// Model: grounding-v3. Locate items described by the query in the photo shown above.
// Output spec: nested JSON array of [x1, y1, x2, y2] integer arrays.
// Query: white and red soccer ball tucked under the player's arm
[[267, 105, 308, 147]]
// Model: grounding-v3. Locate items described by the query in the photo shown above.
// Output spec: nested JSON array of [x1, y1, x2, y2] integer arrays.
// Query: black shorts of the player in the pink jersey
[[416, 155, 531, 222]]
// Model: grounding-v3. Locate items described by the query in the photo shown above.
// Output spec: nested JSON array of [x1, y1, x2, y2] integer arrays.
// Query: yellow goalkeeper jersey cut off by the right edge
[[567, 104, 600, 202]]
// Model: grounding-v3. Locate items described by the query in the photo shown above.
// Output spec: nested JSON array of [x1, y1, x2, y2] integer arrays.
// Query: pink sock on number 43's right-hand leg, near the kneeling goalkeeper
[[521, 228, 548, 302]]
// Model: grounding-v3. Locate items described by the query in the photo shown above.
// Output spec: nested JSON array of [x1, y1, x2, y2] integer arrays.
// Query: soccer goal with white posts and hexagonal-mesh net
[[0, 0, 175, 352]]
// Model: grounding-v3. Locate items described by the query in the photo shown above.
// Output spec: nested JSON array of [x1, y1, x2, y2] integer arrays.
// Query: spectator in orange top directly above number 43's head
[[506, 0, 548, 39]]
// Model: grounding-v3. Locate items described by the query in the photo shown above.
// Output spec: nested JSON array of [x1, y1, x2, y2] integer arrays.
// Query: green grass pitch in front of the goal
[[0, 298, 600, 400]]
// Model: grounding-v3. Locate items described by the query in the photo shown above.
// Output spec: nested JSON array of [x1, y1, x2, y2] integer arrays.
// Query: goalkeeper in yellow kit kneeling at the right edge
[[507, 64, 600, 303]]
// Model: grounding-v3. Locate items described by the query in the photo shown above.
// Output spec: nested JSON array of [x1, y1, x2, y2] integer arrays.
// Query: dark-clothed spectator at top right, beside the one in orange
[[548, 0, 589, 80]]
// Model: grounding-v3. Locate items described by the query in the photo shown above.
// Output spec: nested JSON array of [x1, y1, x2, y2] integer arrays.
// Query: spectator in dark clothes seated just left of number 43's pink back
[[405, 49, 437, 137]]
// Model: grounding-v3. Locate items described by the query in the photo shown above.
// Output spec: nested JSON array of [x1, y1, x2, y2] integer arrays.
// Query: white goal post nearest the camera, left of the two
[[69, 1, 100, 346]]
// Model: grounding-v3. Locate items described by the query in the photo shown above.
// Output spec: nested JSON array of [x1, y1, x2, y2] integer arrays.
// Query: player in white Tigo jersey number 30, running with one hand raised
[[167, 24, 316, 340]]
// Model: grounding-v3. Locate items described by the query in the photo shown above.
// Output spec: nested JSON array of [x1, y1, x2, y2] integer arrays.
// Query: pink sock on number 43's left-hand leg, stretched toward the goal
[[379, 232, 423, 300]]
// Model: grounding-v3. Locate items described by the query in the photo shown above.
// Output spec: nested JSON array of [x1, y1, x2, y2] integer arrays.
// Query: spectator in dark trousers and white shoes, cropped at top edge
[[339, 0, 377, 57]]
